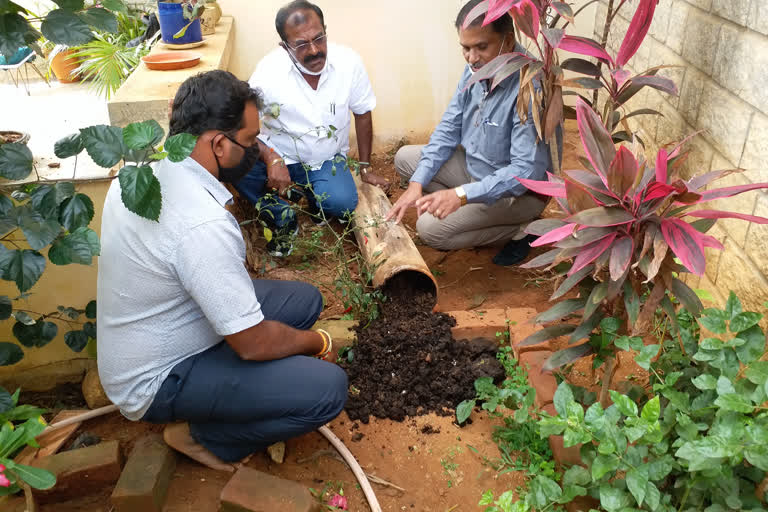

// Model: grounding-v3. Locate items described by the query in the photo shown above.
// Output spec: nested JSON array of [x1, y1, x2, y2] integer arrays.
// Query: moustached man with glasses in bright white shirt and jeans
[[235, 0, 388, 252]]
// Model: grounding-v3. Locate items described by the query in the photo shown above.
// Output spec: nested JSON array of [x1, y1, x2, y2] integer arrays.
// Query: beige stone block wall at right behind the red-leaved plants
[[595, 0, 768, 311]]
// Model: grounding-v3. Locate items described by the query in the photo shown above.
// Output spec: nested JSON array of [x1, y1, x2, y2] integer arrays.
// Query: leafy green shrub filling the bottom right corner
[[504, 294, 768, 512]]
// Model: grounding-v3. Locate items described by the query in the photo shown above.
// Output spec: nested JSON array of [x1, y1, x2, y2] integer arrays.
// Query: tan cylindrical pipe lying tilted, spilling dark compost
[[354, 176, 437, 301]]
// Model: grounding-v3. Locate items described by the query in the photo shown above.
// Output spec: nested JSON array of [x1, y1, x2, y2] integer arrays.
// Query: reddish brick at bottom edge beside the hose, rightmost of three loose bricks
[[219, 468, 320, 512]]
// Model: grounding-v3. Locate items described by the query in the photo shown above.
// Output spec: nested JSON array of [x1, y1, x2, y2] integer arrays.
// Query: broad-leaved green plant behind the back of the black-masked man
[[0, 121, 196, 366]]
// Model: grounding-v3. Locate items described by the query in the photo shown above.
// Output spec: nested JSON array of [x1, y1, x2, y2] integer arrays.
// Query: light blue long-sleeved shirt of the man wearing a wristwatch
[[411, 46, 551, 204]]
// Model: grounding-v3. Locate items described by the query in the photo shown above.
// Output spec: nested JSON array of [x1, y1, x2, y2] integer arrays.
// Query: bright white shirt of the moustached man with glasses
[[249, 43, 376, 169]]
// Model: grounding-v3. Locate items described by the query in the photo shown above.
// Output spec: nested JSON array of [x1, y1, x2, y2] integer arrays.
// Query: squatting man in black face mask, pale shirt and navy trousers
[[97, 71, 347, 471]]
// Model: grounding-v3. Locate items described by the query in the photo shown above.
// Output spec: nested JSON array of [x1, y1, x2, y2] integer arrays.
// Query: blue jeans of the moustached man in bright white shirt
[[235, 155, 357, 229]]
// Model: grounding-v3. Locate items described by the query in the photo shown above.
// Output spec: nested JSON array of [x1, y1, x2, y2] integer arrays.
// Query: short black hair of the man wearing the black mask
[[169, 69, 264, 136]]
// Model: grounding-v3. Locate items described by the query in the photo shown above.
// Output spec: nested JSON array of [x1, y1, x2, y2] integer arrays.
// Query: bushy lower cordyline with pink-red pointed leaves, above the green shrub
[[519, 100, 768, 382]]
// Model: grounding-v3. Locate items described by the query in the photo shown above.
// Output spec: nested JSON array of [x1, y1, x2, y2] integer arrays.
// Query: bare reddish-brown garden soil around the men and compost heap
[[4, 125, 608, 512]]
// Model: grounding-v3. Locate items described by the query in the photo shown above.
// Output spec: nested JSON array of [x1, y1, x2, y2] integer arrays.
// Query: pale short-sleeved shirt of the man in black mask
[[96, 158, 264, 420]]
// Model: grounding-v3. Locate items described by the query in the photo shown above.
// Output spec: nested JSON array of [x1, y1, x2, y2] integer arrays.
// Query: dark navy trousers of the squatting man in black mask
[[142, 280, 347, 462]]
